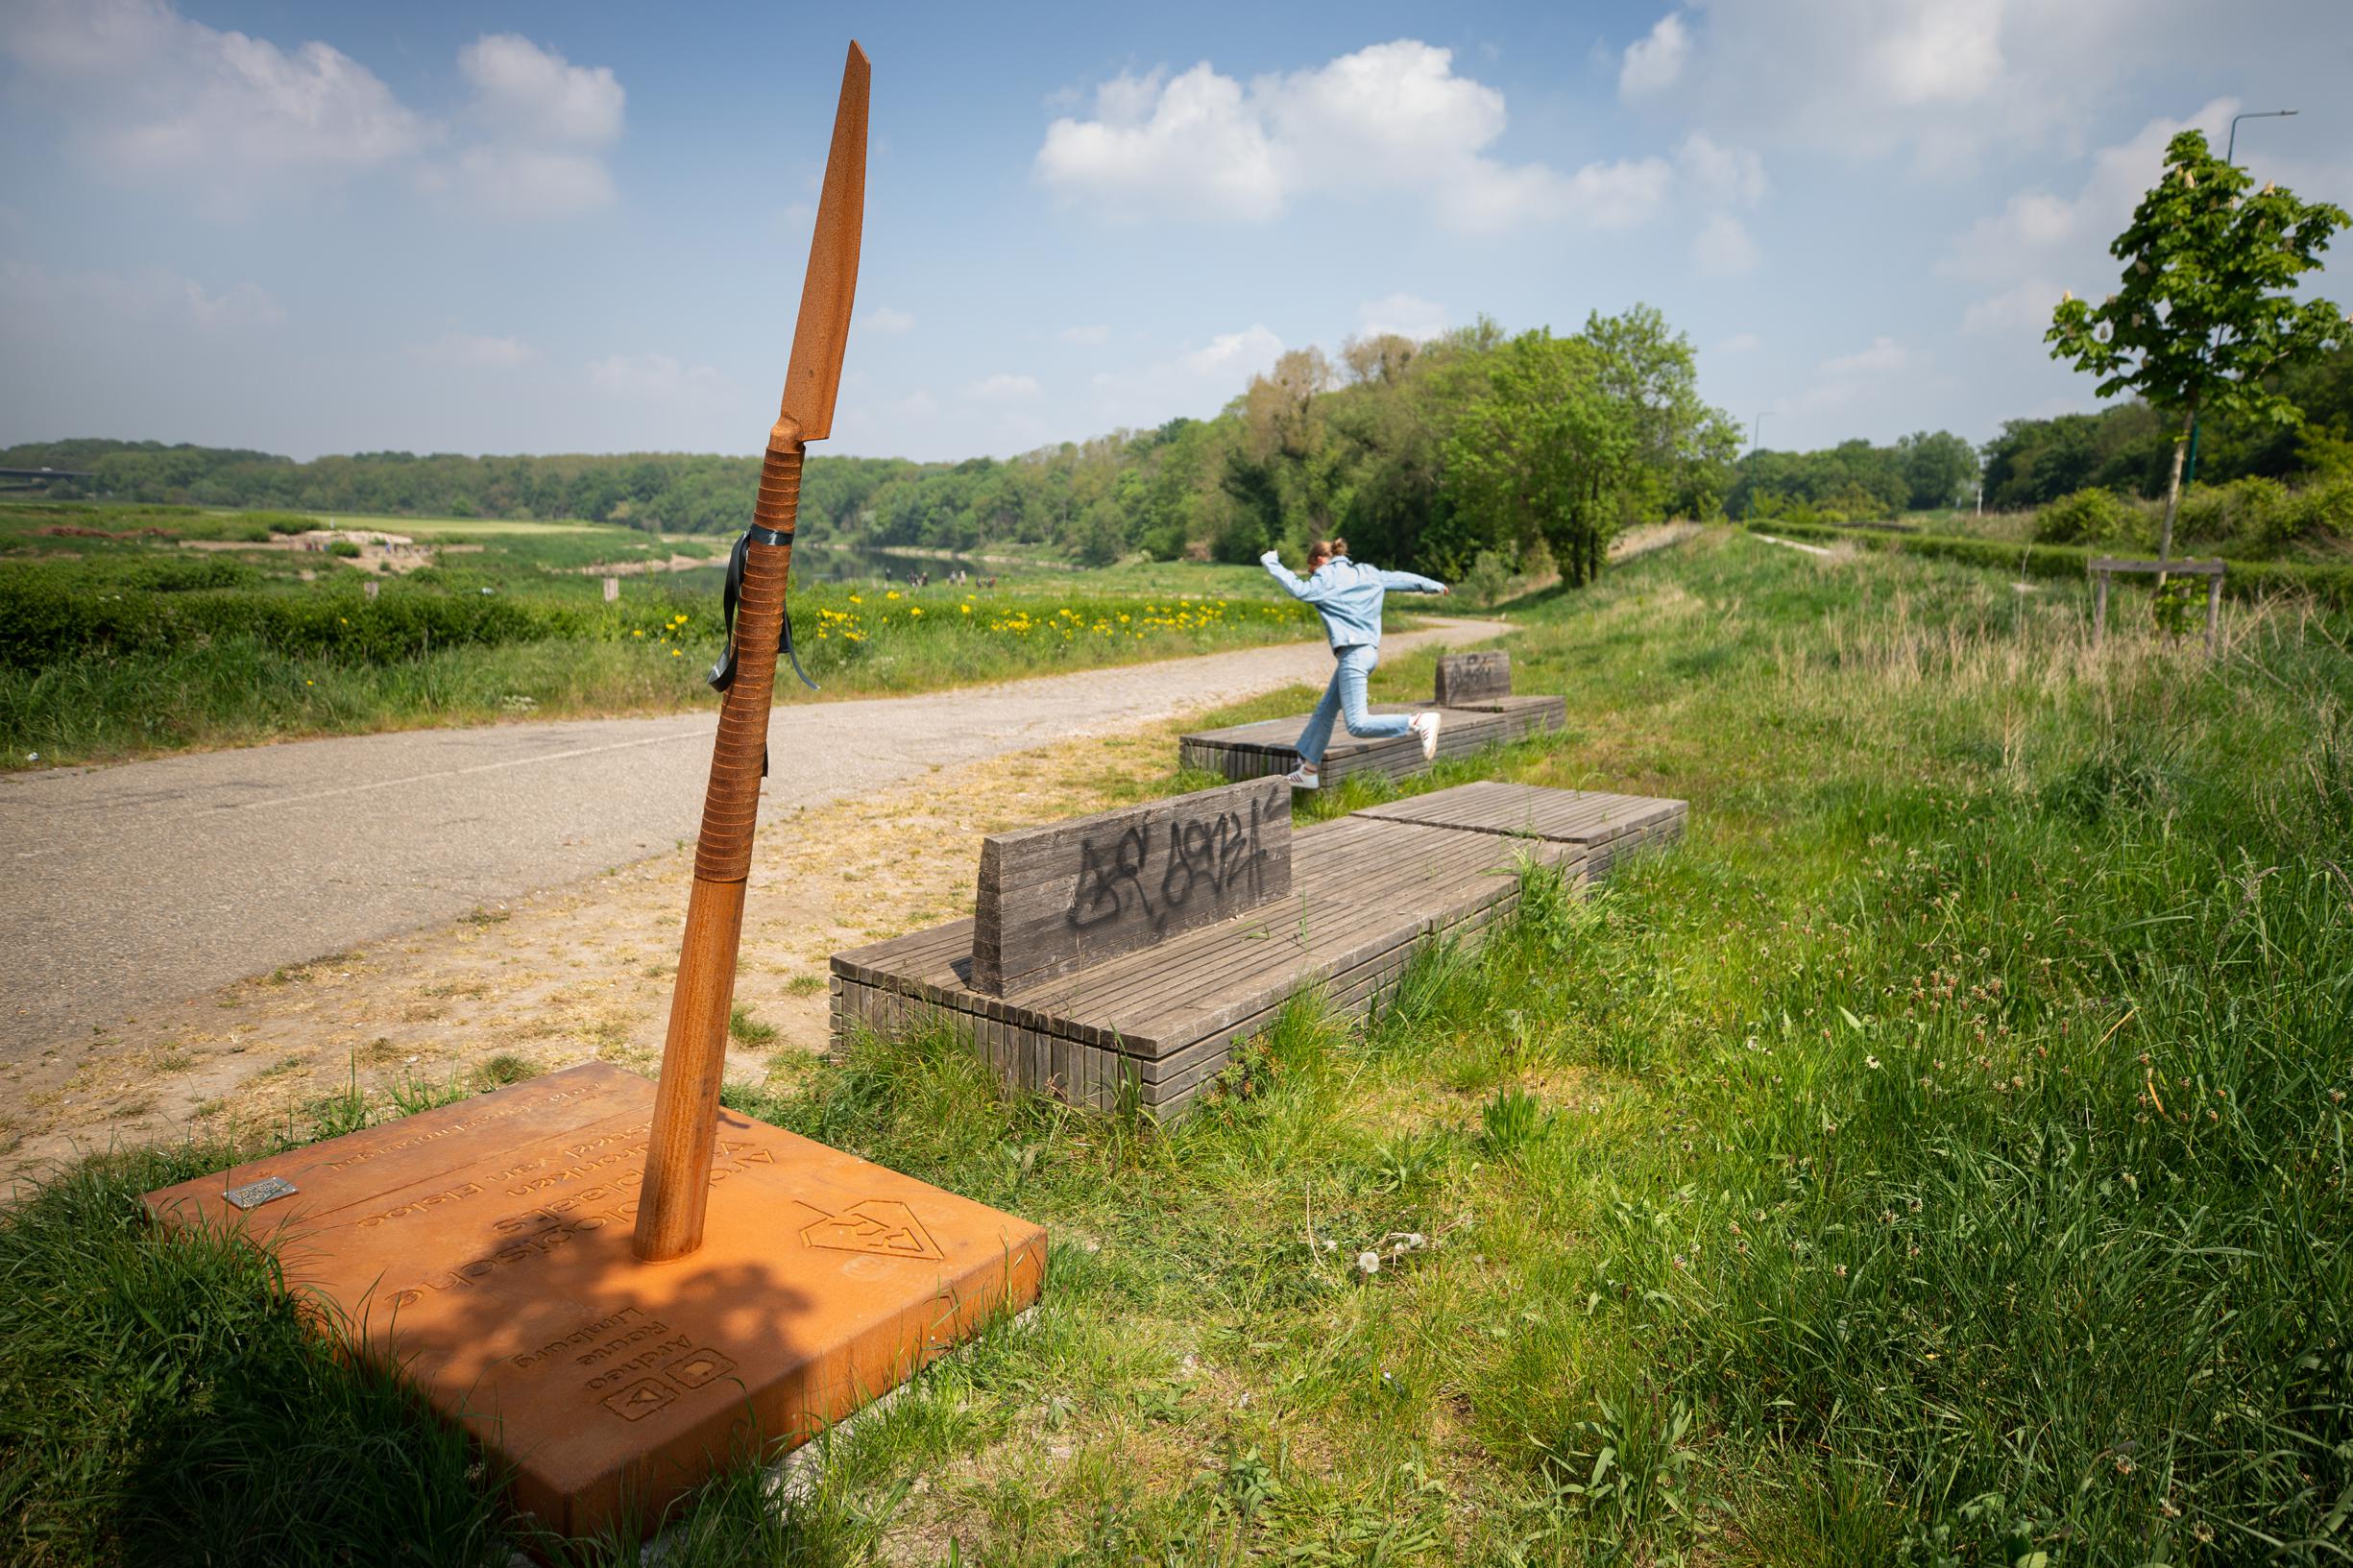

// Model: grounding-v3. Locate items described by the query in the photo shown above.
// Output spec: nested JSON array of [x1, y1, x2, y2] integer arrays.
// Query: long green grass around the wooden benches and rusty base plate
[[0, 534, 2353, 1563]]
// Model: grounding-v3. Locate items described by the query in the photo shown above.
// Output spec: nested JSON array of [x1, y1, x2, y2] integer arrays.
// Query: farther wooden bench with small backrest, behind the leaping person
[[1176, 654, 1569, 783]]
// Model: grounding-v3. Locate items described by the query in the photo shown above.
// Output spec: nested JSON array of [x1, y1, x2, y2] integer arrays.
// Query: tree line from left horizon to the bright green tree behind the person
[[0, 305, 1739, 578]]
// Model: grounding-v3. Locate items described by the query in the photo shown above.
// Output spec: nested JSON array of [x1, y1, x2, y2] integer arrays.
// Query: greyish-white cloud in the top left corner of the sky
[[0, 0, 428, 205]]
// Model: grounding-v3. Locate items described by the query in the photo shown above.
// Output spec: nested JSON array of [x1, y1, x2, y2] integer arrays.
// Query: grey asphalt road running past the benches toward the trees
[[0, 620, 1499, 1055]]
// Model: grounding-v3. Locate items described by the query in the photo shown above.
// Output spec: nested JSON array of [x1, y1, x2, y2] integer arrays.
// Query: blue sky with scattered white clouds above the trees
[[0, 0, 2353, 458]]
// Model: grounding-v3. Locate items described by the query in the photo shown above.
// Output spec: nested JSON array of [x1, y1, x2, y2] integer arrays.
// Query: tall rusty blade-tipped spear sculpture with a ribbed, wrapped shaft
[[633, 42, 868, 1263]]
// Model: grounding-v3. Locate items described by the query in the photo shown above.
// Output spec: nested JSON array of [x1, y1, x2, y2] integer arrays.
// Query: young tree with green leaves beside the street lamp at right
[[2043, 132, 2348, 562]]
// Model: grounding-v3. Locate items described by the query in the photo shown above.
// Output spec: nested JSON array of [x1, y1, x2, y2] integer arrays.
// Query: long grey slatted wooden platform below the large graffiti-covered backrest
[[831, 783, 1685, 1117]]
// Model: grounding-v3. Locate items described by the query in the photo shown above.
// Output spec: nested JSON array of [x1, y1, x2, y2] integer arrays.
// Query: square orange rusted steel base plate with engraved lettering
[[146, 1063, 1045, 1535]]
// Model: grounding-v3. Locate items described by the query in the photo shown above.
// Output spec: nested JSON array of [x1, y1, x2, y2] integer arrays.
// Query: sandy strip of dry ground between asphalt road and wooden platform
[[0, 719, 1271, 1170]]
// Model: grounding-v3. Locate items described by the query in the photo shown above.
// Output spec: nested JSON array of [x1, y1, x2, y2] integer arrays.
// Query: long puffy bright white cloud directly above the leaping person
[[1035, 37, 1673, 232]]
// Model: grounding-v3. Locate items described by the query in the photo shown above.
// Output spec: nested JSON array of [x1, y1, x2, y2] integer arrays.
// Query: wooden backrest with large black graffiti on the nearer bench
[[972, 778, 1292, 997]]
